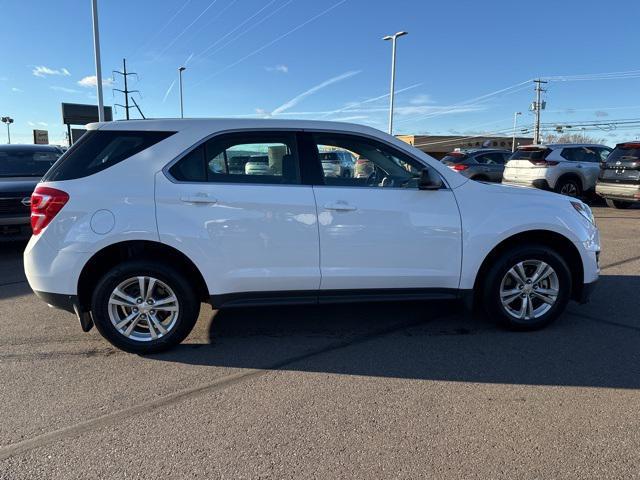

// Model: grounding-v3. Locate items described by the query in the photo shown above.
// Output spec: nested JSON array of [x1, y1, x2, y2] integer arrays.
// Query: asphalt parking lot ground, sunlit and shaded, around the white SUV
[[0, 207, 640, 479]]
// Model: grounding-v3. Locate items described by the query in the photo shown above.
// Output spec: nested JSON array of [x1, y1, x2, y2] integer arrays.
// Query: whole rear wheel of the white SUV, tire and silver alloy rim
[[91, 261, 200, 354]]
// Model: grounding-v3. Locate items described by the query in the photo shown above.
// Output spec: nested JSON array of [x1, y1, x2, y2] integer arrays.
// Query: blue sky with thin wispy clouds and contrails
[[0, 0, 640, 143]]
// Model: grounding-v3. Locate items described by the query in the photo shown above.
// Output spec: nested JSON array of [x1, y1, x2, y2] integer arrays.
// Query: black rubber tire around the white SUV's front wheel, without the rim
[[480, 244, 572, 331]]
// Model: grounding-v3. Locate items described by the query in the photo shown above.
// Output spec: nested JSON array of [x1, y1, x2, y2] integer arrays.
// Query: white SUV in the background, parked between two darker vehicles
[[502, 143, 611, 197]]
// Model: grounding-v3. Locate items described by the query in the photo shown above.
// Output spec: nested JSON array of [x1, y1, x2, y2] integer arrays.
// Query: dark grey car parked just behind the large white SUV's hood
[[441, 148, 511, 182]]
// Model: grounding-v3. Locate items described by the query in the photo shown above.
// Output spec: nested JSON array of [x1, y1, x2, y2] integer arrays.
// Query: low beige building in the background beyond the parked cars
[[396, 135, 533, 159]]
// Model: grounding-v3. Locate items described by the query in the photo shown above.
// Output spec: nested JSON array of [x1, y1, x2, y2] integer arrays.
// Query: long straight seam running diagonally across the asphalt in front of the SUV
[[0, 312, 447, 461]]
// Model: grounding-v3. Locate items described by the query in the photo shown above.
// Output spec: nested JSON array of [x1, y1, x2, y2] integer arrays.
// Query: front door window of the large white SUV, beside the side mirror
[[314, 134, 426, 188]]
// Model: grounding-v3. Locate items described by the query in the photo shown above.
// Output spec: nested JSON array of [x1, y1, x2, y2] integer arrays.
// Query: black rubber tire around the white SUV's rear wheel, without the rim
[[91, 260, 200, 354]]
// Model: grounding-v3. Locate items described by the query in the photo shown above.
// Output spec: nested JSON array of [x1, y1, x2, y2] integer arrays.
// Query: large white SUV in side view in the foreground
[[25, 119, 600, 353]]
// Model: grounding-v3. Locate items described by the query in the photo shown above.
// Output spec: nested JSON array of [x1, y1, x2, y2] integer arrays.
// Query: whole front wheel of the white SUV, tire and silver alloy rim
[[483, 245, 571, 330]]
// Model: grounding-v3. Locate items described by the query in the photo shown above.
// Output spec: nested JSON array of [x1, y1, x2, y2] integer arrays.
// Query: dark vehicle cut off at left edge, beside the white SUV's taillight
[[0, 145, 63, 240]]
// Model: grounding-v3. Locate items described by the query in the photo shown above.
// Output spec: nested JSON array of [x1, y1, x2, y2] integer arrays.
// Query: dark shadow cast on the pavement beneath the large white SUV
[[150, 276, 640, 389]]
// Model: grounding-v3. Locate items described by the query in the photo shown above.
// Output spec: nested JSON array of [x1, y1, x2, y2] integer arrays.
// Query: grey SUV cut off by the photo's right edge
[[596, 142, 640, 208]]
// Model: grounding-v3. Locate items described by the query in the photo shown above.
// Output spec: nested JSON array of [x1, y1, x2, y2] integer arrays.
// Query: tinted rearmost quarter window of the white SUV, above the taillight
[[43, 130, 175, 182]]
